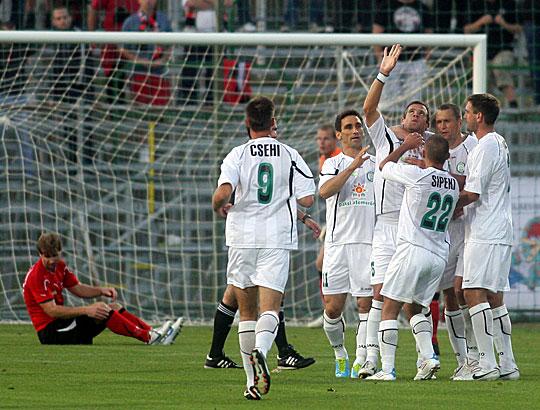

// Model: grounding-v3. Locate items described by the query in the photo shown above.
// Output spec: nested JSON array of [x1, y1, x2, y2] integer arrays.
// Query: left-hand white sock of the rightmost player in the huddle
[[469, 302, 497, 370]]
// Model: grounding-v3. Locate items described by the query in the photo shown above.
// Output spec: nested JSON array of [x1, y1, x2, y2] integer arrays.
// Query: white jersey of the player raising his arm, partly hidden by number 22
[[369, 115, 432, 215]]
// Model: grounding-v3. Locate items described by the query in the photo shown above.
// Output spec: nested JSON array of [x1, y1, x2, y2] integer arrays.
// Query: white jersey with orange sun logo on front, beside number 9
[[319, 153, 375, 245]]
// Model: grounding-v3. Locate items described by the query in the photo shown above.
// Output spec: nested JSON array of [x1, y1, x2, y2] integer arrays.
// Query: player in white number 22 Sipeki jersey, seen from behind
[[366, 133, 459, 381]]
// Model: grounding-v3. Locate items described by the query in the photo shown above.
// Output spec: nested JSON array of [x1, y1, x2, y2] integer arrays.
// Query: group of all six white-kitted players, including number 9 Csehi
[[212, 45, 520, 400]]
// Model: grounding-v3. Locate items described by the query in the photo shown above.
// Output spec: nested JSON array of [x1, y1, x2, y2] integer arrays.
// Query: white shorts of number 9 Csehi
[[227, 247, 290, 293]]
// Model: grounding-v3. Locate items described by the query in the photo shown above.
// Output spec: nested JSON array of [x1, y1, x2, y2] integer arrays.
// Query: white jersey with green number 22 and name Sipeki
[[382, 162, 459, 260]]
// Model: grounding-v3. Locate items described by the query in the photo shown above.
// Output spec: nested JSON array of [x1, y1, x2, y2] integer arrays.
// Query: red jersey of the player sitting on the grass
[[23, 258, 79, 332]]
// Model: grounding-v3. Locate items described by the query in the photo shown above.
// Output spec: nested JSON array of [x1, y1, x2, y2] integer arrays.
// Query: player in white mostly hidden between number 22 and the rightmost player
[[435, 104, 478, 380]]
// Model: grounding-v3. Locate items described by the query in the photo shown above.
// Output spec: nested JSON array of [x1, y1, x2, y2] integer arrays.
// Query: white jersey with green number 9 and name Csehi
[[218, 137, 315, 249]]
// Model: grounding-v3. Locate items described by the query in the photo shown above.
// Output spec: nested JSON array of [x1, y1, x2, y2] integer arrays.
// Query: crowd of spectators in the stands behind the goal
[[0, 0, 540, 108]]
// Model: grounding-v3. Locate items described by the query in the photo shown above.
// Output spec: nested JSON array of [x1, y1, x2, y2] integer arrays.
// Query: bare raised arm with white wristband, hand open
[[363, 44, 401, 127]]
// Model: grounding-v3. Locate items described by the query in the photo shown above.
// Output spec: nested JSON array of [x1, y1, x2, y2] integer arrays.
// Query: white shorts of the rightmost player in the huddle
[[461, 242, 512, 292]]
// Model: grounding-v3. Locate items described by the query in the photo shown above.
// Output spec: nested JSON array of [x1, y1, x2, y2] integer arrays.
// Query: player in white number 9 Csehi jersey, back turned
[[212, 97, 315, 400]]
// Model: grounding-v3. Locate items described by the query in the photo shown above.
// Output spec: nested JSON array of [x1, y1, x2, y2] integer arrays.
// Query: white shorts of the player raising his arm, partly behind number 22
[[371, 219, 397, 285]]
